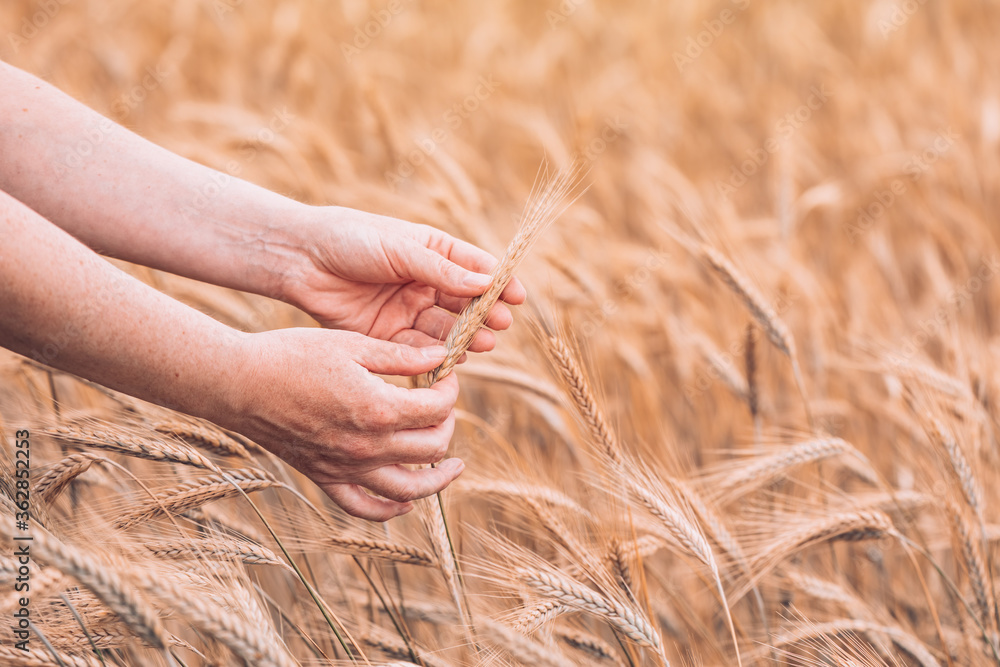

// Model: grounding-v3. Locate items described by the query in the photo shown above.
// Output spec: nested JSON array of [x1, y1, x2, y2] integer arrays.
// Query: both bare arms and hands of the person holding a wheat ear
[[0, 62, 525, 521]]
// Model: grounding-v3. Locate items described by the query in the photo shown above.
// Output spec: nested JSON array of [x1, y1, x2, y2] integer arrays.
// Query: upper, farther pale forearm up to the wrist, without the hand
[[0, 62, 308, 298]]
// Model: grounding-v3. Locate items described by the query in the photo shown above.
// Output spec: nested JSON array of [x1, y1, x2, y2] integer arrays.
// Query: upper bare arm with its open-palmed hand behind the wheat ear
[[0, 62, 525, 352]]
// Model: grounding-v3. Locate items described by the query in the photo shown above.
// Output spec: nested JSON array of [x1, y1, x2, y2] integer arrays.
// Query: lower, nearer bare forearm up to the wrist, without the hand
[[0, 192, 246, 420]]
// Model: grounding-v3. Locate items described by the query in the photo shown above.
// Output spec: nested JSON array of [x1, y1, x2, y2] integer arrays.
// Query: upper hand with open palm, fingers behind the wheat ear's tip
[[283, 207, 526, 352]]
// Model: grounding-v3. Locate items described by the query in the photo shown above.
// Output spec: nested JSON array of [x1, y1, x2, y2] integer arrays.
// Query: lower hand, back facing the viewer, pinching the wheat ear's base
[[226, 329, 465, 521]]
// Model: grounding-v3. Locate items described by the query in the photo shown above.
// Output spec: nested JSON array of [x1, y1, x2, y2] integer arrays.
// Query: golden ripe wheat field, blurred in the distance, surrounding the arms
[[0, 0, 1000, 667]]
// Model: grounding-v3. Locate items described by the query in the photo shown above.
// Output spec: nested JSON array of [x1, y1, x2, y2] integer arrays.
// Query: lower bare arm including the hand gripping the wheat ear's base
[[0, 192, 462, 520]]
